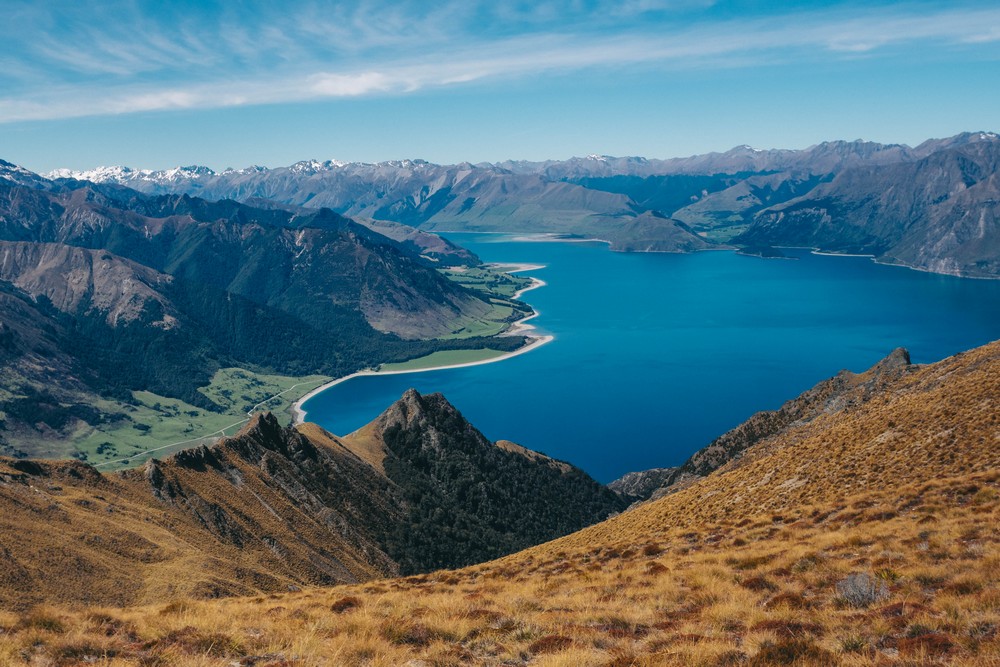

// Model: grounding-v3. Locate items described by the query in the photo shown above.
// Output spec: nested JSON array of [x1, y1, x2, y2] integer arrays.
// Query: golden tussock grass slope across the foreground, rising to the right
[[0, 343, 1000, 666]]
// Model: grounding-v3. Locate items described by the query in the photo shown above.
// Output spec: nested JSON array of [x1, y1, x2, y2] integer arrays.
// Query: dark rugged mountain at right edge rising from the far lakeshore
[[734, 139, 1000, 278]]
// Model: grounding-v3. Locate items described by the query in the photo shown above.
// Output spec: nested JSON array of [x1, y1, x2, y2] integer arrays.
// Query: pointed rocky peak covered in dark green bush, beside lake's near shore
[[344, 389, 624, 573]]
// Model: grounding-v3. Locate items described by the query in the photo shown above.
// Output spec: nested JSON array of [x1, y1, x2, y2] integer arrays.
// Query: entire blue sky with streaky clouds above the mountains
[[0, 0, 1000, 171]]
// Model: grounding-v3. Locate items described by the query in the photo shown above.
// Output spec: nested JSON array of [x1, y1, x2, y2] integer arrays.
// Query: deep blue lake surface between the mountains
[[304, 234, 1000, 482]]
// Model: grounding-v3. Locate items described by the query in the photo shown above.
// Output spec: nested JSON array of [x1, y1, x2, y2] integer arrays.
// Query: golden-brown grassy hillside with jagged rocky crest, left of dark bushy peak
[[0, 415, 395, 609]]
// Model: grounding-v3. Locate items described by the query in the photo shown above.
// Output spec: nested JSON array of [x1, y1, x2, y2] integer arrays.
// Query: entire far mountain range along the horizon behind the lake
[[49, 132, 1000, 277]]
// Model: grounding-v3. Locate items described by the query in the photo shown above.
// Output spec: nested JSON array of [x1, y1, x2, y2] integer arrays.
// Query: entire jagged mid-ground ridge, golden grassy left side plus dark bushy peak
[[0, 390, 623, 609]]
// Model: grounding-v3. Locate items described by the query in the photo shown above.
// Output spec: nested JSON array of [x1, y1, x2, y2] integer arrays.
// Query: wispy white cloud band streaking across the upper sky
[[0, 0, 1000, 122]]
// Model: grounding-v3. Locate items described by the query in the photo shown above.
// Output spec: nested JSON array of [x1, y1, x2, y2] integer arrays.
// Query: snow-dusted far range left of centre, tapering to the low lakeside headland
[[50, 160, 709, 251]]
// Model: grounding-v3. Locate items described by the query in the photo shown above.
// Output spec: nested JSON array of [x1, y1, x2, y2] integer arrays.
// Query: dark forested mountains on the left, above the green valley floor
[[0, 172, 523, 452]]
